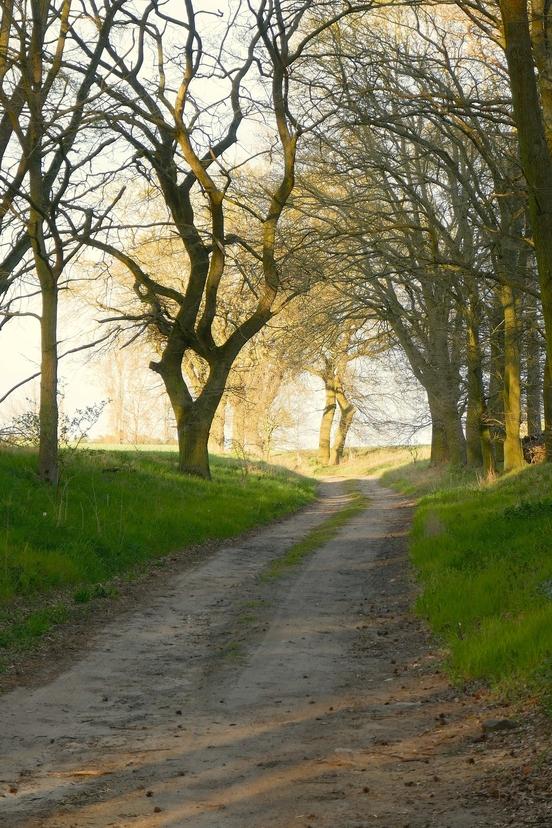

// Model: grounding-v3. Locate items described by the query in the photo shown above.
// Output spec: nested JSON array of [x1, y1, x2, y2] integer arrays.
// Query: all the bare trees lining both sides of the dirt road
[[0, 0, 552, 483]]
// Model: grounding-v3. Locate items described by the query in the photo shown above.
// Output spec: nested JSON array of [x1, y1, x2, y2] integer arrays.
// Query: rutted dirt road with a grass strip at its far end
[[0, 480, 544, 828]]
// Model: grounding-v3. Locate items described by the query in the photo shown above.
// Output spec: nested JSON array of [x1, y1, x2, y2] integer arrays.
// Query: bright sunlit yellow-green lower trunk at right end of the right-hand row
[[500, 285, 525, 471]]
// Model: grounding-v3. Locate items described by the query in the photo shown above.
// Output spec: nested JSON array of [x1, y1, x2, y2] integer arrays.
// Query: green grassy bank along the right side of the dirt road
[[382, 463, 552, 696]]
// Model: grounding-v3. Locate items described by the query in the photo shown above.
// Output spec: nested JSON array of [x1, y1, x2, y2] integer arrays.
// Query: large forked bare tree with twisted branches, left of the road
[[74, 0, 369, 477]]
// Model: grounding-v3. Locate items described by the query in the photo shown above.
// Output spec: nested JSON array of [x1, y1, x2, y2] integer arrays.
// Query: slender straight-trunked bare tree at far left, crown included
[[0, 0, 122, 484]]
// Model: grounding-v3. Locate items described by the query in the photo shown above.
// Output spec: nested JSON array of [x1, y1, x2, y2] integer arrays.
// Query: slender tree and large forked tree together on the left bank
[[0, 0, 376, 483]]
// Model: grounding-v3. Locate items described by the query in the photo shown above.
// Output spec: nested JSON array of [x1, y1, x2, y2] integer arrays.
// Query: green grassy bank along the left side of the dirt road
[[0, 450, 315, 668]]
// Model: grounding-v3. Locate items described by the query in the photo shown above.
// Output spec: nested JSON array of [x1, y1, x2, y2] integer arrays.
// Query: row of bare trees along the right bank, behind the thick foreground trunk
[[294, 8, 551, 473]]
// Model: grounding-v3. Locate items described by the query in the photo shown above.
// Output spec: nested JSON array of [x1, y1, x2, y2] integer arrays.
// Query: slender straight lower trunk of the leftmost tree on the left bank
[[38, 284, 59, 485]]
